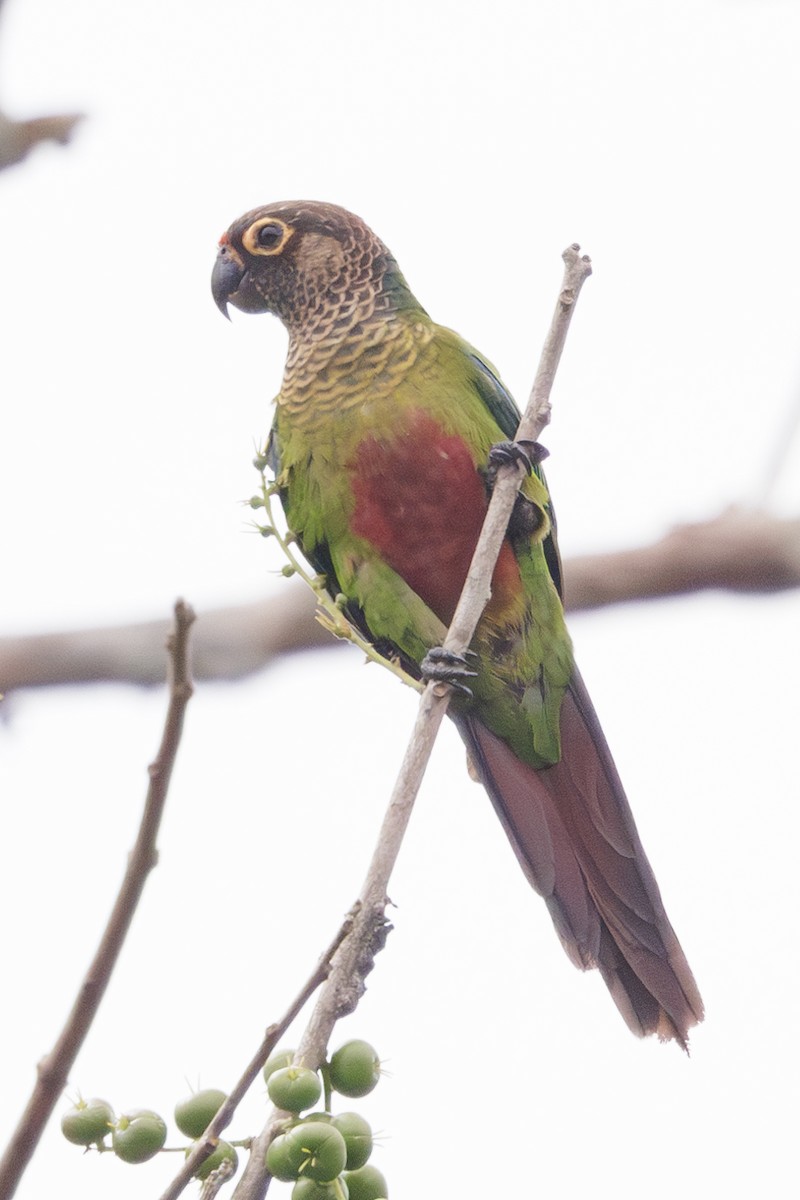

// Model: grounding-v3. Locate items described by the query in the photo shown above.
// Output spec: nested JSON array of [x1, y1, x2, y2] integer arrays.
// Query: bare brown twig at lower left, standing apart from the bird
[[0, 600, 194, 1200]]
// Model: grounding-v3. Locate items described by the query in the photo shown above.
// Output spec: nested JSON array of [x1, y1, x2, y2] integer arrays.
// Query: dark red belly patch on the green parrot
[[350, 410, 521, 624]]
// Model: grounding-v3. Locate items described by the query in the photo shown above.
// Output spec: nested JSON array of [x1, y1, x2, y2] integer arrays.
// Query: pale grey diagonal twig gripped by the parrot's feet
[[234, 246, 591, 1200]]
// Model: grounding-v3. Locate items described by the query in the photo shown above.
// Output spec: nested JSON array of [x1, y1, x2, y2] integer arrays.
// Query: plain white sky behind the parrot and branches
[[0, 0, 800, 1200]]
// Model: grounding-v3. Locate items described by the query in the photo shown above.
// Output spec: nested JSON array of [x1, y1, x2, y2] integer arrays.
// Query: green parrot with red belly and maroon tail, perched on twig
[[212, 200, 703, 1048]]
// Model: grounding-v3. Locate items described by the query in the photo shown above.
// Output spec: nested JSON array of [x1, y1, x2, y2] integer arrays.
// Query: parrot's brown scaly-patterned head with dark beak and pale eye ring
[[211, 200, 419, 336]]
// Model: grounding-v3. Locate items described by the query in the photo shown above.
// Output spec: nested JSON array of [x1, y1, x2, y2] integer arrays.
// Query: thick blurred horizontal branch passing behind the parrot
[[0, 509, 800, 694]]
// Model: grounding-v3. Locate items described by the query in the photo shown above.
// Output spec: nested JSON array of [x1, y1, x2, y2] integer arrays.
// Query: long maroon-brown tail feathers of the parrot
[[457, 672, 703, 1049]]
